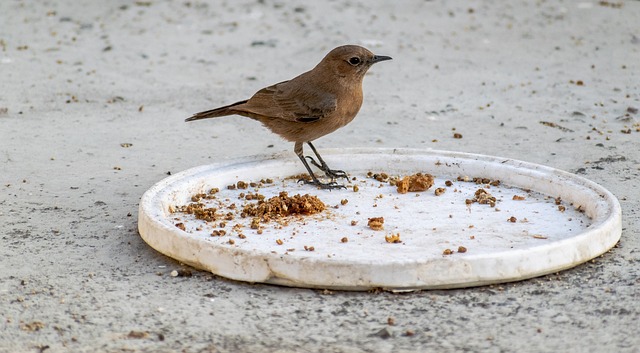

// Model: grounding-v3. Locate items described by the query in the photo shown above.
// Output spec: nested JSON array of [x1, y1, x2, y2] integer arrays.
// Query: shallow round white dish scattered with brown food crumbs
[[139, 149, 621, 291]]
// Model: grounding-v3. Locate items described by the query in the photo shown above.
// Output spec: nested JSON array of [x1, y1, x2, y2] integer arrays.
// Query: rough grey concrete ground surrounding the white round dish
[[0, 0, 640, 352]]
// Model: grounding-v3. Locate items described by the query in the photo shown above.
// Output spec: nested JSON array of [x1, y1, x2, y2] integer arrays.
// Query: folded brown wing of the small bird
[[238, 81, 337, 122]]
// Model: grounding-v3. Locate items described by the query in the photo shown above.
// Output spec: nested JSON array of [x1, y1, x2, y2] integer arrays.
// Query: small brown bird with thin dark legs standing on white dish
[[186, 45, 391, 189]]
